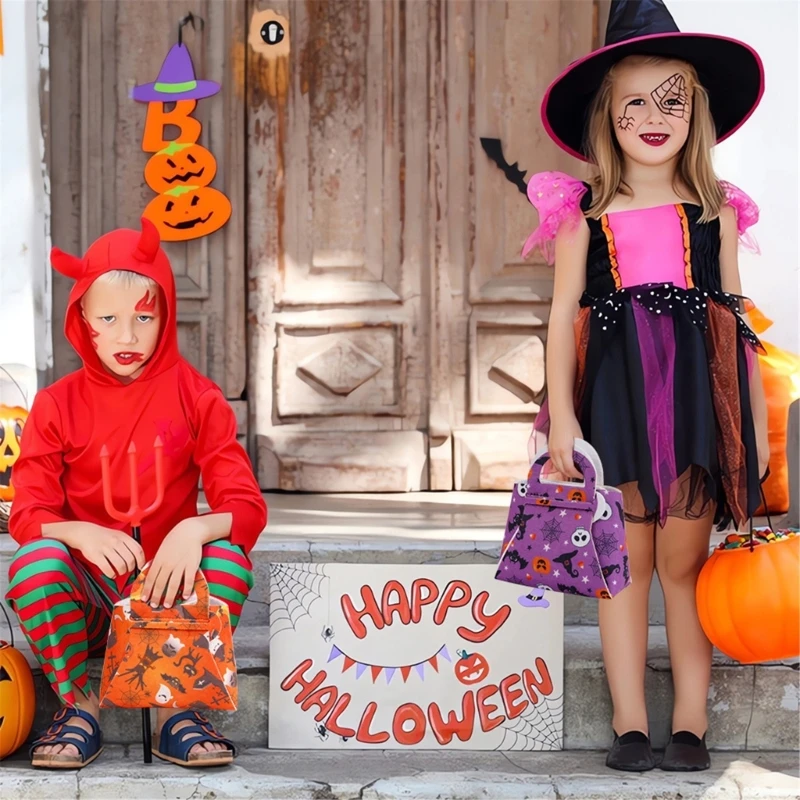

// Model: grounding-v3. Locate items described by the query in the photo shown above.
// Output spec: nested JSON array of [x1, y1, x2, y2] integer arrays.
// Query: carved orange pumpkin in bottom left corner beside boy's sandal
[[0, 642, 36, 759]]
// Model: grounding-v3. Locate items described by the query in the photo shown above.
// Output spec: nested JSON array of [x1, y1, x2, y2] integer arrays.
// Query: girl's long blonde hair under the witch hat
[[586, 56, 724, 222]]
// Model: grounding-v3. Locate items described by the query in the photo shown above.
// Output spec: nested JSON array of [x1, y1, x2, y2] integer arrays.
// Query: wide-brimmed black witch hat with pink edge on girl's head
[[542, 0, 764, 161]]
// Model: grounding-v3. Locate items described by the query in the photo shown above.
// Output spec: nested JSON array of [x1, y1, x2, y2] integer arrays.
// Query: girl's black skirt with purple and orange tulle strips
[[535, 284, 760, 525]]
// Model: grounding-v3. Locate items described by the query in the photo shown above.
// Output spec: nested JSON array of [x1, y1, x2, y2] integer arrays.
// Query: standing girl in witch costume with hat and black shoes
[[523, 0, 768, 771]]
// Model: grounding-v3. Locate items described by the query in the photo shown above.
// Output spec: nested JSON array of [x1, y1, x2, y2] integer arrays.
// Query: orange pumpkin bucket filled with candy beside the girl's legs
[[697, 532, 800, 664]]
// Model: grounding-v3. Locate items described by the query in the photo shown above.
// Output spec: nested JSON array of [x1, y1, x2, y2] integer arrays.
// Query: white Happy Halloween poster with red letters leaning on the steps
[[269, 564, 563, 750]]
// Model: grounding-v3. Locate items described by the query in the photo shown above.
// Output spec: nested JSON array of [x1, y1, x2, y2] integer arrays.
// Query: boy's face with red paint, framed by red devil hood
[[82, 281, 161, 380]]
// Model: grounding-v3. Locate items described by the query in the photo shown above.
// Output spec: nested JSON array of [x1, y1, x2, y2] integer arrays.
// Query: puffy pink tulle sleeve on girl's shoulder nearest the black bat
[[522, 172, 586, 264]]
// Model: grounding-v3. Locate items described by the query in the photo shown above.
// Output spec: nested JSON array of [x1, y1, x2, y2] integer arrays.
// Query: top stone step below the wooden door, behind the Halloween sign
[[0, 492, 740, 625]]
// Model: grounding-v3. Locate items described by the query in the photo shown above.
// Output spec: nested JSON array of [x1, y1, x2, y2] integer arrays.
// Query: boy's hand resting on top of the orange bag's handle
[[142, 518, 204, 608]]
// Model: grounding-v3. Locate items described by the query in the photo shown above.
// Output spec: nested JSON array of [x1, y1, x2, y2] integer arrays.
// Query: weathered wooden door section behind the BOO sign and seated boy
[[47, 0, 247, 438]]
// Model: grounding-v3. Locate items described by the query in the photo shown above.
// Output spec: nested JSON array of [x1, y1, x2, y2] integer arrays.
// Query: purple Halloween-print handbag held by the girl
[[495, 440, 631, 598]]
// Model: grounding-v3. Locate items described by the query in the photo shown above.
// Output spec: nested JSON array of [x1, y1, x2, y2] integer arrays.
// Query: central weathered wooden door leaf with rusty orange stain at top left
[[247, 0, 433, 491]]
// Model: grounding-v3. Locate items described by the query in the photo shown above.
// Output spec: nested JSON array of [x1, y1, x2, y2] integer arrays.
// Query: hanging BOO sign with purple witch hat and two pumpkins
[[132, 14, 231, 242]]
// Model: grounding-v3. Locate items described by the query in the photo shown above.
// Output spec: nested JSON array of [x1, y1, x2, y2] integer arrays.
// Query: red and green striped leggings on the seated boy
[[6, 539, 253, 705]]
